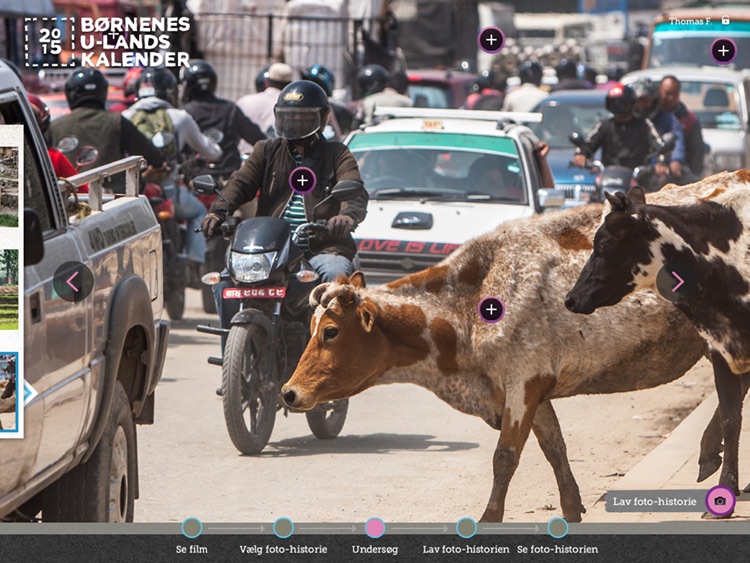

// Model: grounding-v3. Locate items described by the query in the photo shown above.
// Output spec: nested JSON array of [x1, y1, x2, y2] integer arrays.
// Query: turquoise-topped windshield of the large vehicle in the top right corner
[[648, 20, 750, 70]]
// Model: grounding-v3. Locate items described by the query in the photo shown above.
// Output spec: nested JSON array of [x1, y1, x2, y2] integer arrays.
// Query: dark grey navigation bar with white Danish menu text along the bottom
[[2, 534, 750, 563]]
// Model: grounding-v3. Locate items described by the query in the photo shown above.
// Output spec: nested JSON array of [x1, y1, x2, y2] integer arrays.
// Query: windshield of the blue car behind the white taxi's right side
[[531, 100, 612, 150]]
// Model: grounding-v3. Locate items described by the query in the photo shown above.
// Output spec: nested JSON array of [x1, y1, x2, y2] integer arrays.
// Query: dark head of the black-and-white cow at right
[[565, 187, 658, 315]]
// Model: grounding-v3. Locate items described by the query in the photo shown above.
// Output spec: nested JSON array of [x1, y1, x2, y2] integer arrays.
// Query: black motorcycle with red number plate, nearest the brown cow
[[193, 175, 361, 454]]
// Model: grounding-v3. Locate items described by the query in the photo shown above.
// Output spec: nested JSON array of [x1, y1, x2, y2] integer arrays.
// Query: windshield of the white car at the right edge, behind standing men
[[680, 81, 750, 131]]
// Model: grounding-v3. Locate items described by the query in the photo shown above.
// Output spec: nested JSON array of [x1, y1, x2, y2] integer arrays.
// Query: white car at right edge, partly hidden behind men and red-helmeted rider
[[622, 67, 750, 172]]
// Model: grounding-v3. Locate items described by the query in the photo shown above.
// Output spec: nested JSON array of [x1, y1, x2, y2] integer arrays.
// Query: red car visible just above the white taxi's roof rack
[[406, 70, 476, 109]]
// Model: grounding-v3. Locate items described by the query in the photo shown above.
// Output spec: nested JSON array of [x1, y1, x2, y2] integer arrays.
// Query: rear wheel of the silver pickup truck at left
[[42, 381, 137, 522]]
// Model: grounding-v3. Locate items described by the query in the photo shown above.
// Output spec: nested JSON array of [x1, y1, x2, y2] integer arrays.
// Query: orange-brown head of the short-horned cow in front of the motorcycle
[[281, 272, 388, 410]]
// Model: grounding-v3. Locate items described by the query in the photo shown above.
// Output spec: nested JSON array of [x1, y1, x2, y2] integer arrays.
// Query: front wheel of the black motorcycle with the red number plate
[[221, 324, 278, 455]]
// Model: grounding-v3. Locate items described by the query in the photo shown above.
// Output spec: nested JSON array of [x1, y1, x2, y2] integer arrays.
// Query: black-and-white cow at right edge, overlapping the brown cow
[[565, 170, 750, 494]]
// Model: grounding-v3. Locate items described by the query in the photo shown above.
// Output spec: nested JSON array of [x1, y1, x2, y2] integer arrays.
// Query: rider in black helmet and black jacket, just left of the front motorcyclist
[[180, 59, 266, 178]]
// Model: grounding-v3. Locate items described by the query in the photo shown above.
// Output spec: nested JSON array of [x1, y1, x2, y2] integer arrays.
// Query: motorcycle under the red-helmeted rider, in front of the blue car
[[568, 132, 675, 198]]
